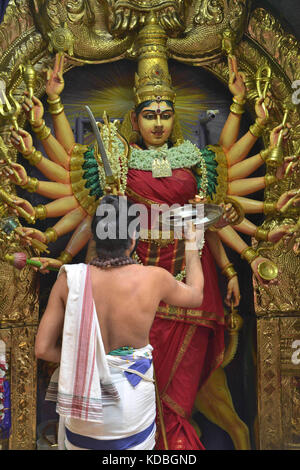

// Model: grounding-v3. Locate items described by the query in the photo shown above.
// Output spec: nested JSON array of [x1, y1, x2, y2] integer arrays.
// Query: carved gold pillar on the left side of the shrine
[[0, 239, 39, 450]]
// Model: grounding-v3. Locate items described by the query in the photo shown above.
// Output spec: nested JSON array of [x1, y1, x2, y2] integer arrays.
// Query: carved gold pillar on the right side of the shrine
[[255, 247, 300, 450]]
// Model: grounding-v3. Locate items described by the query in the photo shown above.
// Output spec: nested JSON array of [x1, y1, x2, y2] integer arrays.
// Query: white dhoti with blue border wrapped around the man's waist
[[65, 345, 156, 450]]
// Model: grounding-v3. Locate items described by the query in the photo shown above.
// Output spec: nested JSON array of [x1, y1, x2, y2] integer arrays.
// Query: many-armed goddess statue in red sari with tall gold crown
[[2, 12, 295, 450]]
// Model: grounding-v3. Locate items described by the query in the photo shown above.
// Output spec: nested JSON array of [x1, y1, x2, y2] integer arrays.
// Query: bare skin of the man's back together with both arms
[[35, 228, 203, 362]]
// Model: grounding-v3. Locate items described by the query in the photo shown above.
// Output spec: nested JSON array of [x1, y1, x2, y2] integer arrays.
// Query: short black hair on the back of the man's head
[[91, 195, 139, 259]]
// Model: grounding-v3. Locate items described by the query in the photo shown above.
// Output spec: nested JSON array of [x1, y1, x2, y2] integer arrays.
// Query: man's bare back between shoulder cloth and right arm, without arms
[[90, 264, 161, 353]]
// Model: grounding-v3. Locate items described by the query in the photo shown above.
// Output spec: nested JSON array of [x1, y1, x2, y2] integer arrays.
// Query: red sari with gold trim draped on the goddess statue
[[126, 169, 224, 450]]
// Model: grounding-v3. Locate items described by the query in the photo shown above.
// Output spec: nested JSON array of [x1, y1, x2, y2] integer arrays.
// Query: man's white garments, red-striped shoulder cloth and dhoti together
[[46, 264, 156, 450]]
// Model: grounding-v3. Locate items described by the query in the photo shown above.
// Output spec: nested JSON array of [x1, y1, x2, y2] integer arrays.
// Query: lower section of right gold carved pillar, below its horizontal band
[[258, 317, 300, 450]]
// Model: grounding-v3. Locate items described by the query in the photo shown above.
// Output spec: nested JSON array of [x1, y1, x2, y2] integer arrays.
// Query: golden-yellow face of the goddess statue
[[133, 101, 174, 147]]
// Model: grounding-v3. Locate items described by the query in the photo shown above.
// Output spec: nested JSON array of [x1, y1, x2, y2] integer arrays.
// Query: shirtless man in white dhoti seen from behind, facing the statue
[[35, 196, 204, 450]]
